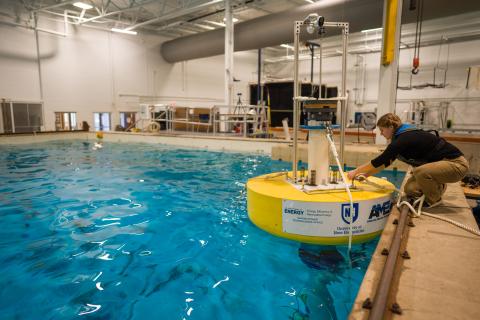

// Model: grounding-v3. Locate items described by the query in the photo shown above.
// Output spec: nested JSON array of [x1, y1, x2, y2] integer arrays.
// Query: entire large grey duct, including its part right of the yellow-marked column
[[161, 0, 480, 63]]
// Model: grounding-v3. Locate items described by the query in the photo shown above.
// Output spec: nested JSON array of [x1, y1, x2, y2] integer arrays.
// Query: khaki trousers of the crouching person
[[404, 156, 468, 204]]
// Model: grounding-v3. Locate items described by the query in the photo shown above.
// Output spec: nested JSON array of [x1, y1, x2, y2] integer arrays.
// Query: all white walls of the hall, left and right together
[[0, 8, 480, 130]]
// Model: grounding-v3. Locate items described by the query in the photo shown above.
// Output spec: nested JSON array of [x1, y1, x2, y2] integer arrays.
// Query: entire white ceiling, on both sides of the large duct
[[0, 0, 480, 58]]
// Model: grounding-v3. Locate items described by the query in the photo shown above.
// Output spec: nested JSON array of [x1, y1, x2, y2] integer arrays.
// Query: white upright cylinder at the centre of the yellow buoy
[[308, 130, 329, 185]]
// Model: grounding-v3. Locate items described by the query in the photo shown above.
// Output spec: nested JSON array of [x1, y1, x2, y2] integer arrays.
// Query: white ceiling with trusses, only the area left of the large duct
[[1, 0, 309, 38]]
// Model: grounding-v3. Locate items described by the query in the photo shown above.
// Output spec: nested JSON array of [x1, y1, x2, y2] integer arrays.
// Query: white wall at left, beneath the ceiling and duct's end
[[0, 14, 257, 130]]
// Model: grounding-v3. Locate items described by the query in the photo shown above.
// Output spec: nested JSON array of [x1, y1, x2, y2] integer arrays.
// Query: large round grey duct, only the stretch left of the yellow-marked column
[[161, 0, 383, 62]]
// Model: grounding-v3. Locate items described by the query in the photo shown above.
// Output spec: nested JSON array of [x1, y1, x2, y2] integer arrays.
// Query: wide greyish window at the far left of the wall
[[1, 101, 43, 133]]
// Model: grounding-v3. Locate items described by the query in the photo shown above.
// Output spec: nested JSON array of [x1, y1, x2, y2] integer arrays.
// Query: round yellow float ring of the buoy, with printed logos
[[247, 173, 394, 245]]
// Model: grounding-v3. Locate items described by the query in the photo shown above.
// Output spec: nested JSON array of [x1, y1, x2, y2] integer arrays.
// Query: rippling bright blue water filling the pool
[[0, 141, 403, 320]]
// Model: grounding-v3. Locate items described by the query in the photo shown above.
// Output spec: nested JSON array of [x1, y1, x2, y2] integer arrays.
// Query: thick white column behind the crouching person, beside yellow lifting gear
[[375, 0, 402, 144]]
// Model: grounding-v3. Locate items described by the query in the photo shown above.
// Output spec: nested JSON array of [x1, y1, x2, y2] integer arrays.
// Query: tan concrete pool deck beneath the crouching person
[[349, 183, 480, 320]]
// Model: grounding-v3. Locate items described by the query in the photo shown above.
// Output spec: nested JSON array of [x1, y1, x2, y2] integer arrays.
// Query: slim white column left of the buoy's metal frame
[[225, 0, 234, 105]]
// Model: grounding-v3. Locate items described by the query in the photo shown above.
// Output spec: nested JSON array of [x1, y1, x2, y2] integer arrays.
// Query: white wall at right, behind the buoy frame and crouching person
[[265, 40, 480, 128]]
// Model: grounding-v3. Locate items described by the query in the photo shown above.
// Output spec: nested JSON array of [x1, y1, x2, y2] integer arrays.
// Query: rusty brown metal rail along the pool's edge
[[368, 205, 409, 320]]
